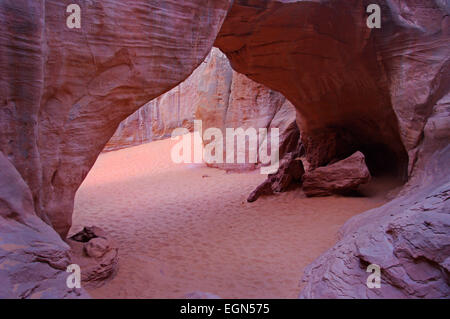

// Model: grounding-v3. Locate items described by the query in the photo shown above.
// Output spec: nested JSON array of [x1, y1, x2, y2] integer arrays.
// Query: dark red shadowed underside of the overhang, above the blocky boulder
[[216, 0, 418, 178]]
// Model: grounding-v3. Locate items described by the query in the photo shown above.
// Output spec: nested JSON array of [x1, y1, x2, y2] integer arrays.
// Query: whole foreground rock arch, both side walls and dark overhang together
[[0, 0, 450, 298]]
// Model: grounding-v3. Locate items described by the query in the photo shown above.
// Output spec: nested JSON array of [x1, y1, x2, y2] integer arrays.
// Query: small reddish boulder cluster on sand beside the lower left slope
[[68, 226, 119, 288]]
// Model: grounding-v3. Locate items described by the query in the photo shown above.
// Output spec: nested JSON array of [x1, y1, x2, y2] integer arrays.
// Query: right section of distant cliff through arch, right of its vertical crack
[[195, 51, 299, 171]]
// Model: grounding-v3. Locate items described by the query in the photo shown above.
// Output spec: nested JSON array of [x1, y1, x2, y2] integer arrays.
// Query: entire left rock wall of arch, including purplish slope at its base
[[0, 0, 230, 298]]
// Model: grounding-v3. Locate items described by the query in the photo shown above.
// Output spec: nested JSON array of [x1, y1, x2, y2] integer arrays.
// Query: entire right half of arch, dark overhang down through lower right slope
[[215, 0, 450, 298]]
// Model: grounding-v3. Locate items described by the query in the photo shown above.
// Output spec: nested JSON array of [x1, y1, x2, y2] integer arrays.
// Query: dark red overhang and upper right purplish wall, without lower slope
[[215, 0, 448, 177]]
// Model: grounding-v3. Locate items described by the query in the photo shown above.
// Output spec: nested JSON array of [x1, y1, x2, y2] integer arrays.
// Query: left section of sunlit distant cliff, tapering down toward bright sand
[[105, 48, 233, 151]]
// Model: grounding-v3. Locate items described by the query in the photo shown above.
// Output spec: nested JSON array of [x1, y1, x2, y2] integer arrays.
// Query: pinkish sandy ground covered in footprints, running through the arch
[[72, 135, 398, 298]]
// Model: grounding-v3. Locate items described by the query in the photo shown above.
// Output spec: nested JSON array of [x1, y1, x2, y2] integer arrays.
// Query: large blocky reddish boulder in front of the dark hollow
[[303, 152, 371, 196]]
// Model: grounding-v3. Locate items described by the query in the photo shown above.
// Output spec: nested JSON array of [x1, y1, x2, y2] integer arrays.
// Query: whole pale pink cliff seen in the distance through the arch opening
[[105, 48, 299, 174]]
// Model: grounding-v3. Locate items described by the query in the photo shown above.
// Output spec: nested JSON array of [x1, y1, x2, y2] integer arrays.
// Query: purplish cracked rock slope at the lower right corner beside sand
[[300, 148, 450, 298]]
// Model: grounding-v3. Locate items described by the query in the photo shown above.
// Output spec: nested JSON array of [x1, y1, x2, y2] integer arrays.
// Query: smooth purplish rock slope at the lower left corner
[[0, 152, 89, 299]]
